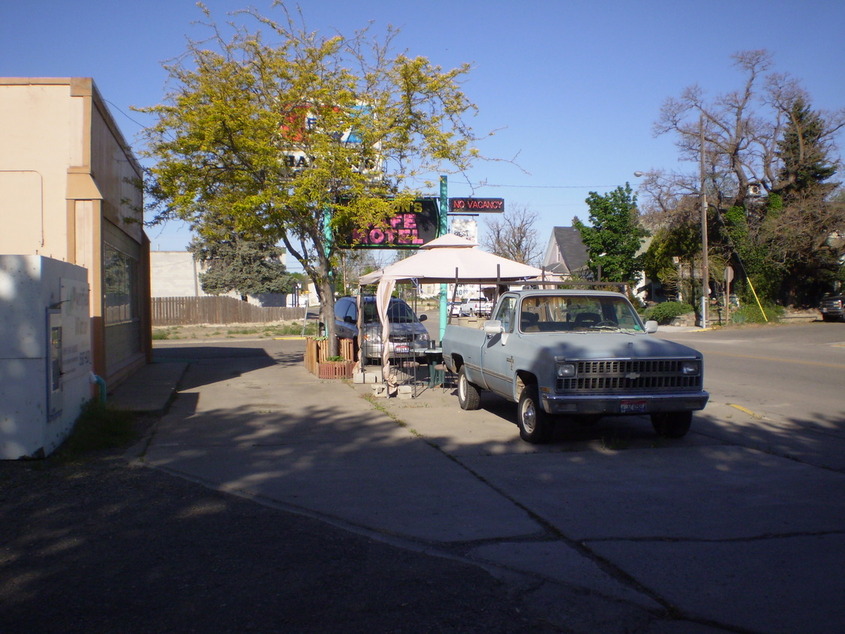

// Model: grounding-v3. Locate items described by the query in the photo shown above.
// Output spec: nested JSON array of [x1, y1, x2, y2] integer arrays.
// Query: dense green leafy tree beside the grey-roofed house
[[572, 183, 648, 282]]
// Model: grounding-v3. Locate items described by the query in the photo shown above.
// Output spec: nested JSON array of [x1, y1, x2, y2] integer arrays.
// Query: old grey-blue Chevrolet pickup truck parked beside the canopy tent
[[443, 289, 709, 443]]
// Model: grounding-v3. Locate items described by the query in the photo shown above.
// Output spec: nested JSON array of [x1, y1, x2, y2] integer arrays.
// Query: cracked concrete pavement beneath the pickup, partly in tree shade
[[135, 324, 845, 632]]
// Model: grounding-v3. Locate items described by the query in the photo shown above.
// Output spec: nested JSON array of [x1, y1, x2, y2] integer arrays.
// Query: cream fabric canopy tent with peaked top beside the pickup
[[360, 233, 543, 372]]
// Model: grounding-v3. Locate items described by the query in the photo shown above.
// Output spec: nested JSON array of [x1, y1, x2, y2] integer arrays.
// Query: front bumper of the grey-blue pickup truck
[[540, 390, 710, 416]]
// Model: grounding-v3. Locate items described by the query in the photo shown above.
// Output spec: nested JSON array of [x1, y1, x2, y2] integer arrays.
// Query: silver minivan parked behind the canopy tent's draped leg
[[334, 295, 429, 362]]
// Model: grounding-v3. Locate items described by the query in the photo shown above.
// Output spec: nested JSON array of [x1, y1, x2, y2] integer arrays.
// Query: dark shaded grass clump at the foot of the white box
[[56, 400, 138, 461]]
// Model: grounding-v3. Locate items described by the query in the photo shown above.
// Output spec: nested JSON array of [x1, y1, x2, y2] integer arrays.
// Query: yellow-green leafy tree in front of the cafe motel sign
[[138, 2, 479, 345]]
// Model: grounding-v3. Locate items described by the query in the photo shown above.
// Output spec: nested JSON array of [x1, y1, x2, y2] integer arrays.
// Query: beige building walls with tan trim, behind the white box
[[0, 78, 149, 380]]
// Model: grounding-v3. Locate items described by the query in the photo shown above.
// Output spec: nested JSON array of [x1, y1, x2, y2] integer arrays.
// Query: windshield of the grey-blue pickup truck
[[519, 295, 643, 333]]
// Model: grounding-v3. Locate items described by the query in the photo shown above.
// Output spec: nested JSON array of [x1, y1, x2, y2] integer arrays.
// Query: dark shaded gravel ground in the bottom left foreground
[[0, 440, 563, 633]]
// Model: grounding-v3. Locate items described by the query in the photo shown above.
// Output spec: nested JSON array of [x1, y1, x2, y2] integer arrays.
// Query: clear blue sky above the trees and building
[[0, 0, 845, 262]]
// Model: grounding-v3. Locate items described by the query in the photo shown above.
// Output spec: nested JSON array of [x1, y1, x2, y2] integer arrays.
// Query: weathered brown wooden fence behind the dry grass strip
[[152, 297, 305, 326]]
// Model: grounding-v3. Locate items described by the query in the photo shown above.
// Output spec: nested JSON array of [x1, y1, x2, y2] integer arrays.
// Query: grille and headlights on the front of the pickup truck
[[555, 359, 703, 394]]
